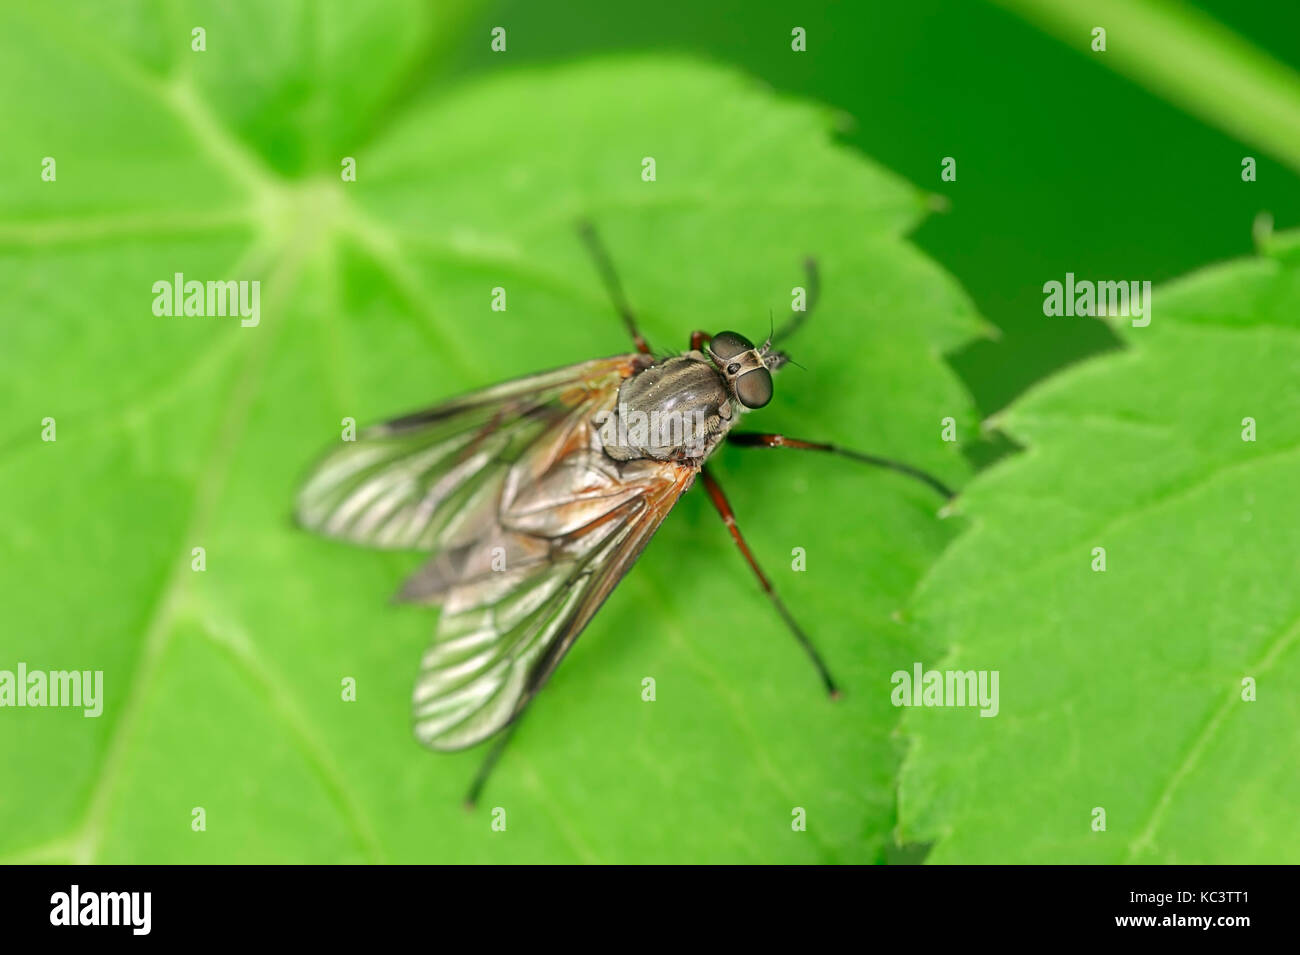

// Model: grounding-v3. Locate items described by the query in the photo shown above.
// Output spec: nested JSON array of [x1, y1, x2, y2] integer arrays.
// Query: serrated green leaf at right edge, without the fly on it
[[900, 235, 1300, 863]]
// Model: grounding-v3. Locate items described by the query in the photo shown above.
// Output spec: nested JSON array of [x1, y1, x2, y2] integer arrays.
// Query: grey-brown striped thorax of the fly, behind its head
[[595, 352, 736, 461]]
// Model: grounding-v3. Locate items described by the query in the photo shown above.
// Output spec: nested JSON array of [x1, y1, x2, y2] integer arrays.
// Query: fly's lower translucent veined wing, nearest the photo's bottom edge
[[407, 454, 697, 750]]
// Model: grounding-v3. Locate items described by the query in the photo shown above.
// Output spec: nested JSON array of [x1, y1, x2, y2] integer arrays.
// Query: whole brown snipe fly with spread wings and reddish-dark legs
[[296, 223, 952, 804]]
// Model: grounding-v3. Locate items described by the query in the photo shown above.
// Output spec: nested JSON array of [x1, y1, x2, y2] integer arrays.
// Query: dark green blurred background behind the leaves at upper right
[[455, 0, 1300, 414]]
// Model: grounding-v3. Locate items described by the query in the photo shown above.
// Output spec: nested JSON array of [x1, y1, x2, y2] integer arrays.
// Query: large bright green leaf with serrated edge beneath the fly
[[0, 3, 982, 861]]
